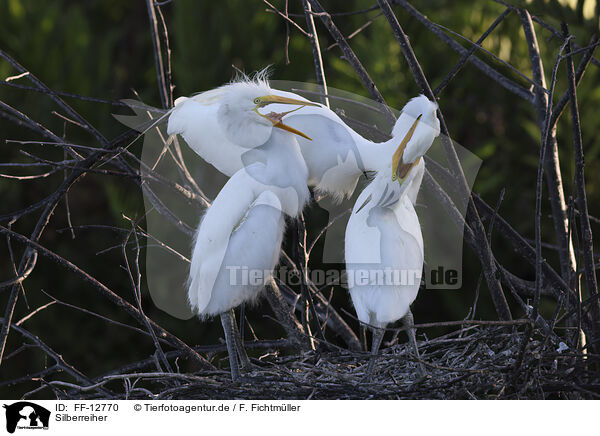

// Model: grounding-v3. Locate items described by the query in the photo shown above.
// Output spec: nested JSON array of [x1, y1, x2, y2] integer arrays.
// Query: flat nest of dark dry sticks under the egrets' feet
[[48, 324, 600, 400]]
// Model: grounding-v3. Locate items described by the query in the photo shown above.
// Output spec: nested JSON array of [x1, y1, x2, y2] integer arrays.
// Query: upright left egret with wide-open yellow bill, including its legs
[[188, 81, 310, 380]]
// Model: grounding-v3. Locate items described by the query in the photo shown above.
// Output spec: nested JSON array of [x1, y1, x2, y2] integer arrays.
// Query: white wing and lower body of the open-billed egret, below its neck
[[188, 180, 284, 317]]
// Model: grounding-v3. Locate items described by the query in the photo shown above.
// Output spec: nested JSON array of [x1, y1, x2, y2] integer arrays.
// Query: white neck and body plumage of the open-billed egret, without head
[[188, 129, 309, 317]]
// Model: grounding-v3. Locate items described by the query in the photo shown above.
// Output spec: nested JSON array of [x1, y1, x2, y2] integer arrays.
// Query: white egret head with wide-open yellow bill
[[217, 80, 318, 148]]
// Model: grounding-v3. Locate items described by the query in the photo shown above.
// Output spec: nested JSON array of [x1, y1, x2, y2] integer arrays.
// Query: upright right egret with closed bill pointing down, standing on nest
[[345, 96, 440, 379]]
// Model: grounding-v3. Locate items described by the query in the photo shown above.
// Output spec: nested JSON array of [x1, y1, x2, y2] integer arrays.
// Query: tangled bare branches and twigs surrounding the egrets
[[0, 0, 600, 399]]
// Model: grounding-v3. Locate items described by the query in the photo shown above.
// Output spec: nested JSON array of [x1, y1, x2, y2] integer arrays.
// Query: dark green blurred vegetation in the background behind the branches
[[0, 0, 600, 398]]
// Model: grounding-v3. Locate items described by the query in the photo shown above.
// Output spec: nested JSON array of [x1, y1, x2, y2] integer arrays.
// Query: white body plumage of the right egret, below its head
[[345, 163, 424, 328]]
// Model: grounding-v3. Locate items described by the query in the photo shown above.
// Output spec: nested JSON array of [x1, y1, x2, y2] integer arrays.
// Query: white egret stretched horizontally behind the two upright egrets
[[167, 80, 435, 200]]
